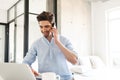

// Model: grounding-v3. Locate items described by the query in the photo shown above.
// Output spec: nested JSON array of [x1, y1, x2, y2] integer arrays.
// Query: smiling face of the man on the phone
[[39, 20, 52, 38]]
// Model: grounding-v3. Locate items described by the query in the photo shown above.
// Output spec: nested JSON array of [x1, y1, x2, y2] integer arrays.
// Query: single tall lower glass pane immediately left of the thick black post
[[15, 15, 24, 63]]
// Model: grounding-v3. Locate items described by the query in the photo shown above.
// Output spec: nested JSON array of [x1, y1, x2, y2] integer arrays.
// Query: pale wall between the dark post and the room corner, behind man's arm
[[58, 0, 91, 55]]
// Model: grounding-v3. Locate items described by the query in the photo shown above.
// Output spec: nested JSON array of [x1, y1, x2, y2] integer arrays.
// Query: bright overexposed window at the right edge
[[107, 8, 120, 66]]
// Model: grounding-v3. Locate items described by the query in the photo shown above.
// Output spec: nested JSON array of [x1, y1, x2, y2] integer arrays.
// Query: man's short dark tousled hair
[[37, 11, 54, 23]]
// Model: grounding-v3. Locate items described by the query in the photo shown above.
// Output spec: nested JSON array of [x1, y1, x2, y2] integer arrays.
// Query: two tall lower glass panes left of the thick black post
[[9, 16, 24, 63]]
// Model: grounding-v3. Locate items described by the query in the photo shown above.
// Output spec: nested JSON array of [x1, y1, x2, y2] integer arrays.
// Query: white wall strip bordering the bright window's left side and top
[[92, 0, 120, 63]]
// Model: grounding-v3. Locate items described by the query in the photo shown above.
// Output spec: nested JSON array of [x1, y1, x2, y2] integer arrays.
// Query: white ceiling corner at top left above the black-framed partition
[[0, 0, 19, 10]]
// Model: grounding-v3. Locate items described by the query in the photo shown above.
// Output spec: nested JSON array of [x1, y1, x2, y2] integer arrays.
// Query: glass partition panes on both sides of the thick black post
[[8, 0, 46, 63]]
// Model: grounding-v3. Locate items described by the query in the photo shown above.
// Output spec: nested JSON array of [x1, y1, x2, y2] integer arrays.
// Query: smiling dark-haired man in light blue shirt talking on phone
[[23, 11, 77, 80]]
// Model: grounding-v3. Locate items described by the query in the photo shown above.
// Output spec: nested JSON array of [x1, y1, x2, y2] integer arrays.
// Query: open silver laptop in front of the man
[[0, 63, 39, 80]]
